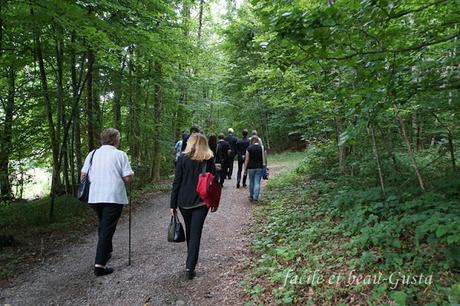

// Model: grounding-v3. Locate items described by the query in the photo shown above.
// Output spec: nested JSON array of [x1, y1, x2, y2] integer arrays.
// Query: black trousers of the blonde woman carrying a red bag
[[179, 206, 208, 271]]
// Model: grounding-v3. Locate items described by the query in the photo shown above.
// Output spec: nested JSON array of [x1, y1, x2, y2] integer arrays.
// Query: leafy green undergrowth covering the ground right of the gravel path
[[243, 146, 460, 305]]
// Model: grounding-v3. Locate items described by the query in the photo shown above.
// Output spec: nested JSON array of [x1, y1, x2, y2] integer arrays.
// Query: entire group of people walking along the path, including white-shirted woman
[[81, 126, 266, 279]]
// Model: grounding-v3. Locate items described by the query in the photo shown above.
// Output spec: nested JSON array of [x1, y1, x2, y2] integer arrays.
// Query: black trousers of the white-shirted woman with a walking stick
[[90, 203, 123, 266]]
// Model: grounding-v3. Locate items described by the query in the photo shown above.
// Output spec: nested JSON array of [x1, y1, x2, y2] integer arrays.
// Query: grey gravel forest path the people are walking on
[[0, 163, 280, 306]]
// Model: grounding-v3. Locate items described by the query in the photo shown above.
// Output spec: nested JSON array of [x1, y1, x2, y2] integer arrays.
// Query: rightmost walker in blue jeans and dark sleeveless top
[[244, 136, 266, 202]]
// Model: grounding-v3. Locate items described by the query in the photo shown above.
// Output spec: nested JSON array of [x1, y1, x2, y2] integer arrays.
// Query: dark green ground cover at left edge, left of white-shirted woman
[[0, 196, 94, 279]]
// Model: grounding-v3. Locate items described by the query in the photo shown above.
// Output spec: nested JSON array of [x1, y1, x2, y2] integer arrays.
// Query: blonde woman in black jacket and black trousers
[[170, 133, 217, 279]]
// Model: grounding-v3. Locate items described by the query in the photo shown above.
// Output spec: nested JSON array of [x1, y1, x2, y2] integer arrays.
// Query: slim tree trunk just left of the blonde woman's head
[[152, 61, 162, 182]]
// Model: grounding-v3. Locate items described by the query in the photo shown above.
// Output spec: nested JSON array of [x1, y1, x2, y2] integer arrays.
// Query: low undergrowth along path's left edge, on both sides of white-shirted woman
[[0, 180, 171, 280]]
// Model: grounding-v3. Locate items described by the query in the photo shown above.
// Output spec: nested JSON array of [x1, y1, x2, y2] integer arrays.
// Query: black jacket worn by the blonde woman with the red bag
[[170, 154, 216, 208]]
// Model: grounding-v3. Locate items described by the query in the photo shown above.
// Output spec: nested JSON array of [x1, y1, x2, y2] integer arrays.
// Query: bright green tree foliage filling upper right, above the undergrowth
[[223, 0, 460, 194]]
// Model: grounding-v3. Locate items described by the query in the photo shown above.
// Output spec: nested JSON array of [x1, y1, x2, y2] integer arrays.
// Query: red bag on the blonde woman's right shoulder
[[196, 163, 222, 208]]
